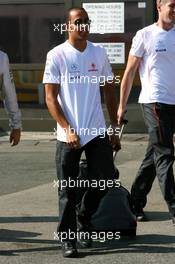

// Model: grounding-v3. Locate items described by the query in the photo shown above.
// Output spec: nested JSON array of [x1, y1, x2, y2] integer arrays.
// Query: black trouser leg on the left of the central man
[[56, 141, 82, 240]]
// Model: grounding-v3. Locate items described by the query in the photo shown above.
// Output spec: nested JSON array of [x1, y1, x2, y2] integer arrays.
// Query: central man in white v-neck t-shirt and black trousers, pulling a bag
[[43, 8, 120, 257]]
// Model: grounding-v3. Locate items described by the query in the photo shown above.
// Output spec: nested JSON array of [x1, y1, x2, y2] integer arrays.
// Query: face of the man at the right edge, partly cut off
[[158, 0, 175, 24]]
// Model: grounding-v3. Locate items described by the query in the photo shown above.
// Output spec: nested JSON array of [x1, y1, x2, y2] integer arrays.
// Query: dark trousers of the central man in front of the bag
[[56, 136, 116, 237]]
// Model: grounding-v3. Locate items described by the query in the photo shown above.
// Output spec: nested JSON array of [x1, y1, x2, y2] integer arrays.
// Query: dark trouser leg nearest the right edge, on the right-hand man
[[154, 103, 175, 216]]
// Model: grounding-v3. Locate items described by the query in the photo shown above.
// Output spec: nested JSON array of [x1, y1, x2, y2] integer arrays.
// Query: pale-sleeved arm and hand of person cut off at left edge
[[0, 51, 21, 146]]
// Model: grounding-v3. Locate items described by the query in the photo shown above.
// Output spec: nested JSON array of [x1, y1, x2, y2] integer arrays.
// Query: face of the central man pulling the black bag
[[68, 10, 90, 40]]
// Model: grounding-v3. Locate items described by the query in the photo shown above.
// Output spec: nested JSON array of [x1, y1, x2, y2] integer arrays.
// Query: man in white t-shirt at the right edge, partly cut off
[[118, 0, 175, 225]]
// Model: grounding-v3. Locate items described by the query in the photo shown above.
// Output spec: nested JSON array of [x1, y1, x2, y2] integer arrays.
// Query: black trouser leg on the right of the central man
[[78, 136, 116, 228]]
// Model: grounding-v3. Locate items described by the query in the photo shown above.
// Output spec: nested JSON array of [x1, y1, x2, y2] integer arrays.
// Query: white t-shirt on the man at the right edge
[[130, 24, 175, 105]]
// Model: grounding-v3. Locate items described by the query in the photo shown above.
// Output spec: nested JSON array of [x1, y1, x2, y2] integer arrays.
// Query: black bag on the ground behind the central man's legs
[[77, 160, 137, 236]]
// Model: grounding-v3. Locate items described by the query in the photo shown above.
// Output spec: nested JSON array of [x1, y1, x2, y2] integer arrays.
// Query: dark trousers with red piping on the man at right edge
[[131, 103, 175, 216]]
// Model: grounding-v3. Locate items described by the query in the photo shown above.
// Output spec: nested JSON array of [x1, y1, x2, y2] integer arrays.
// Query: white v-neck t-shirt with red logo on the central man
[[43, 41, 113, 146]]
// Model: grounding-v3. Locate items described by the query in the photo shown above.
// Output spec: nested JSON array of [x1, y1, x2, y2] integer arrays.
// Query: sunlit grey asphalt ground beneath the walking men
[[0, 132, 175, 264]]
